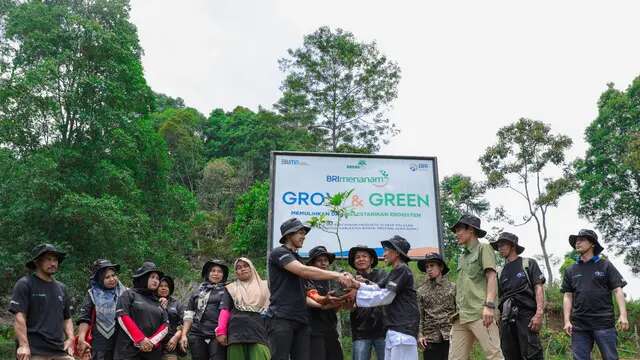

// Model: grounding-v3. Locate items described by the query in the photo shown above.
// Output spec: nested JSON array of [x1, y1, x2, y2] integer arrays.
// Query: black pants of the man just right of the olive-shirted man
[[500, 310, 543, 360]]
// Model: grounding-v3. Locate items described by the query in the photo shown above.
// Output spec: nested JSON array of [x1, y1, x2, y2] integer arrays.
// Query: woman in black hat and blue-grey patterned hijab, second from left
[[77, 259, 126, 360]]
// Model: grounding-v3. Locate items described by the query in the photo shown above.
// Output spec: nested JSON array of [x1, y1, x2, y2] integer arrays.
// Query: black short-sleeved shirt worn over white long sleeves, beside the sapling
[[378, 263, 420, 338]]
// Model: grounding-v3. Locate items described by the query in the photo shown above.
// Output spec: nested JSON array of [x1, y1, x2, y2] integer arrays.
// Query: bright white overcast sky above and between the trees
[[131, 0, 640, 298]]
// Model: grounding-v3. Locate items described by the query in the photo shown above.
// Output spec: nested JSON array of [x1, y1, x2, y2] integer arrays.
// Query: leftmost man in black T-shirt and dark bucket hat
[[9, 244, 74, 360]]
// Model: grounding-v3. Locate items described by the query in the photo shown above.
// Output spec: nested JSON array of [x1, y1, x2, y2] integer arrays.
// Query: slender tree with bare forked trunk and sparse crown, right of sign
[[480, 118, 575, 283]]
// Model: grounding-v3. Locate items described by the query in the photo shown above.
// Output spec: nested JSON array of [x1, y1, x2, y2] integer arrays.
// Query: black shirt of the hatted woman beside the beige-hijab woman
[[187, 284, 229, 338]]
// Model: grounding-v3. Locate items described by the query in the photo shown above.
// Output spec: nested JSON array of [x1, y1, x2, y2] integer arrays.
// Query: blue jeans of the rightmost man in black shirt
[[571, 328, 618, 360]]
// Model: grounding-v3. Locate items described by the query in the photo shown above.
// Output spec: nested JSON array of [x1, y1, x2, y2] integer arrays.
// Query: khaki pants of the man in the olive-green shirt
[[449, 320, 504, 360]]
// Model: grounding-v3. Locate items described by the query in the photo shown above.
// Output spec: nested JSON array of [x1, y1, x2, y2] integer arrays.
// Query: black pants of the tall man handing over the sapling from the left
[[268, 317, 311, 360]]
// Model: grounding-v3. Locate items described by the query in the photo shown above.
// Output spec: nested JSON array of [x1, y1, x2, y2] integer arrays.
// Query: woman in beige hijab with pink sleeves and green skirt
[[216, 257, 271, 360]]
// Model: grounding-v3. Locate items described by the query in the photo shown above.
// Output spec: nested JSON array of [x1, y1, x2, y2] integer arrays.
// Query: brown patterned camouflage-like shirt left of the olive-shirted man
[[417, 277, 456, 343]]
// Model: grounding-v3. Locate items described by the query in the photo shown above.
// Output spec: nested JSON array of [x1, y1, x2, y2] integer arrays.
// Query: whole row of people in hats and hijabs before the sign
[[9, 215, 629, 360]]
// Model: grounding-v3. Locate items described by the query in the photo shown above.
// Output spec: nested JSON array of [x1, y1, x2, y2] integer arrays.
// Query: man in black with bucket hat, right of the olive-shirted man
[[491, 232, 546, 360]]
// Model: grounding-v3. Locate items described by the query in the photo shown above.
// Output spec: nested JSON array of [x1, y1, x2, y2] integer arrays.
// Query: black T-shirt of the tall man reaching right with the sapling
[[269, 246, 309, 324]]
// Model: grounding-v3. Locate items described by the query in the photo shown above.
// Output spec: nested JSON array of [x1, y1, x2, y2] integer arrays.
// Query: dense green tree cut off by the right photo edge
[[576, 77, 640, 273]]
